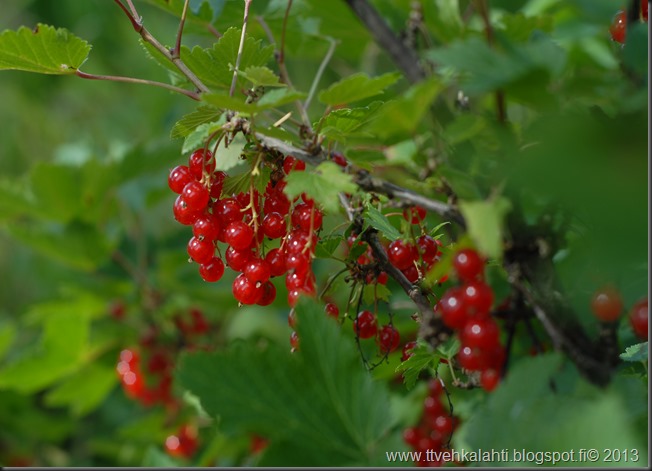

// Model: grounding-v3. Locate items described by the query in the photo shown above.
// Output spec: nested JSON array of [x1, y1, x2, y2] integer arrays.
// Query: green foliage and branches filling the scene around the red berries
[[0, 0, 649, 467]]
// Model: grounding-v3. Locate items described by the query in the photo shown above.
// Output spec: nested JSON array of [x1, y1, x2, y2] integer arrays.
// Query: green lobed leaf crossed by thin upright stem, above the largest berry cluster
[[181, 28, 274, 91]]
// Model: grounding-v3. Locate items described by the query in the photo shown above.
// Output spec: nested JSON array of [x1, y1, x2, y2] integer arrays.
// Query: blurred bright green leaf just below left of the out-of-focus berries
[[45, 363, 117, 417]]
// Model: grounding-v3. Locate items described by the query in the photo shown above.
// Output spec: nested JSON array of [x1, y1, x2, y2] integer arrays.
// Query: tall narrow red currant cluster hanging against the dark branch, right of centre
[[435, 249, 505, 391]]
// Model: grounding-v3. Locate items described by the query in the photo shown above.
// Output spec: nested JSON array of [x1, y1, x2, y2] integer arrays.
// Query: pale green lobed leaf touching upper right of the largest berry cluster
[[283, 162, 357, 213]]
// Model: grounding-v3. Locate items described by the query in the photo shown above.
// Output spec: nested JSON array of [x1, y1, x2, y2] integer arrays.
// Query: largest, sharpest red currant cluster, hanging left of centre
[[168, 149, 323, 306]]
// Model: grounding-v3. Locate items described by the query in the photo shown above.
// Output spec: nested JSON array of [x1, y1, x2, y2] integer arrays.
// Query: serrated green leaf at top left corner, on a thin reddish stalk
[[0, 23, 91, 75]]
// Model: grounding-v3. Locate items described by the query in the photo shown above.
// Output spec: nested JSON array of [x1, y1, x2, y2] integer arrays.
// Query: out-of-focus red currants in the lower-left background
[[116, 308, 210, 458]]
